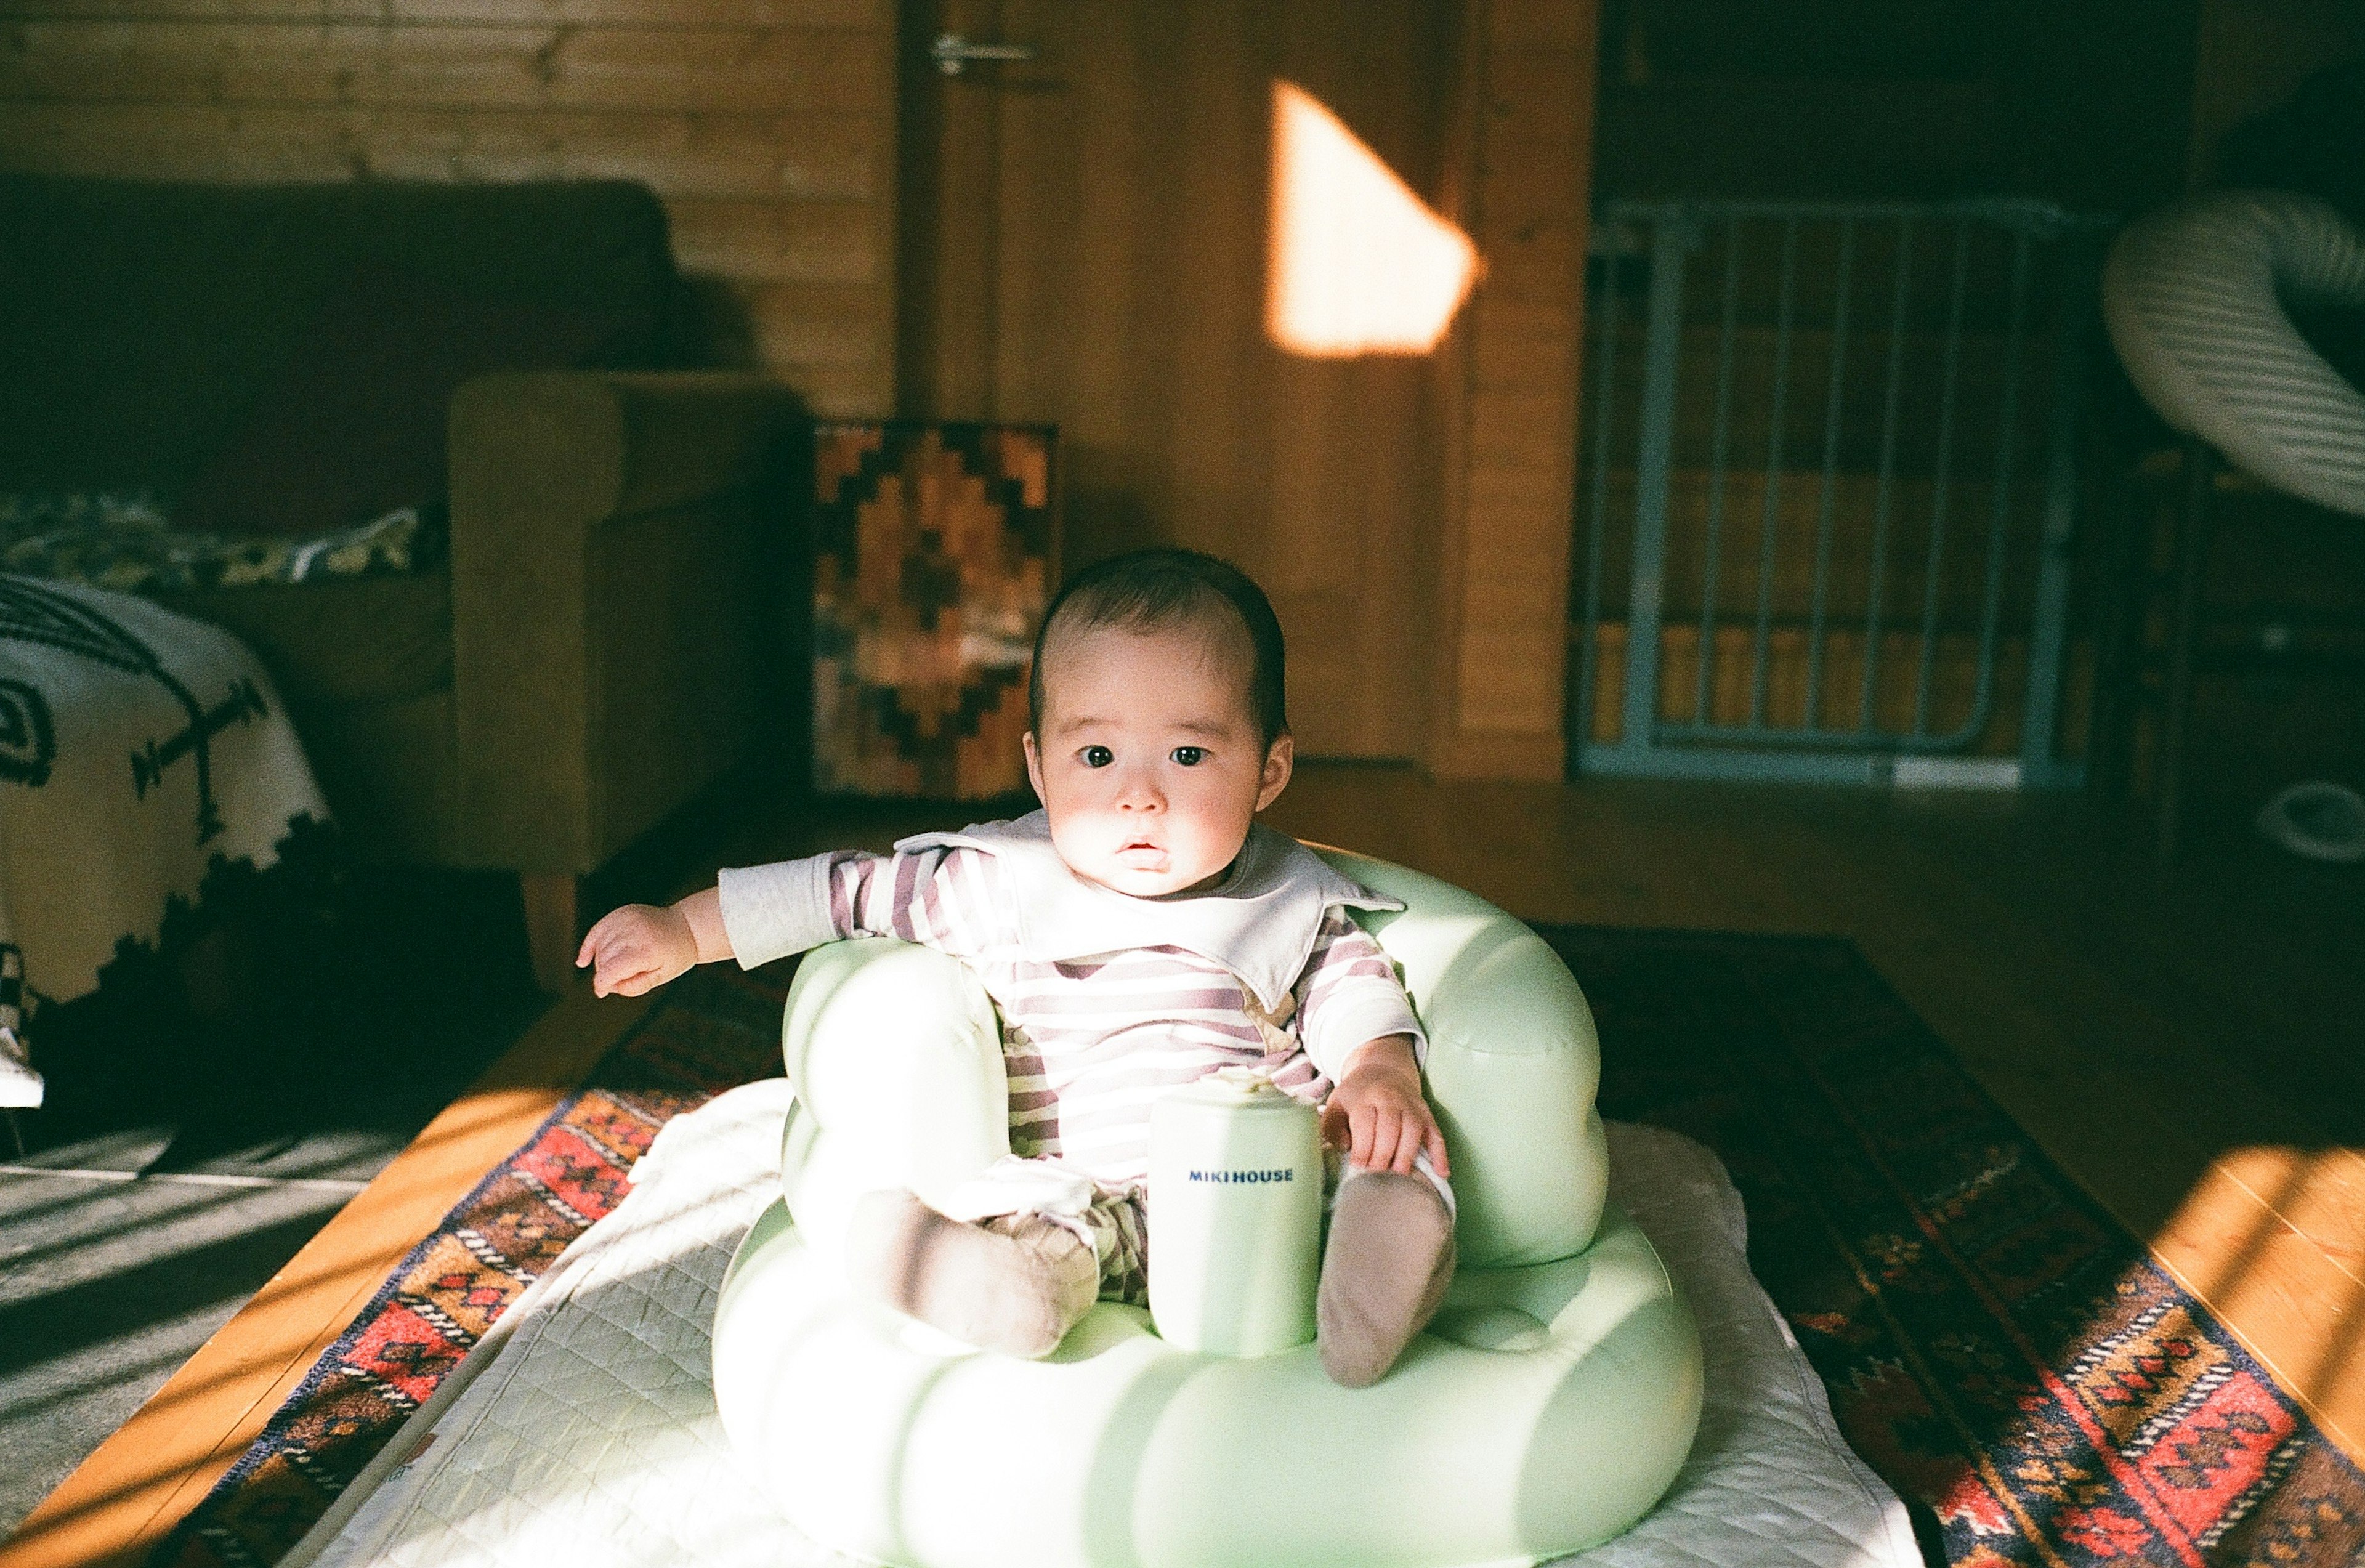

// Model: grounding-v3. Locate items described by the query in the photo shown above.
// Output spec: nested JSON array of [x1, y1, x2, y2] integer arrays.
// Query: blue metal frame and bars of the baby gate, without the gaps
[[1573, 199, 2107, 788]]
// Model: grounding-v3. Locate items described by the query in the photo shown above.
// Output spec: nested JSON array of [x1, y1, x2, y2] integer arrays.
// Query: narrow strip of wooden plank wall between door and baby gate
[[1426, 0, 1601, 780]]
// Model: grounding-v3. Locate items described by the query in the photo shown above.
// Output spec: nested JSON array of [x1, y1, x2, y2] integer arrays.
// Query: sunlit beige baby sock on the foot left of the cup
[[847, 1190, 1100, 1357]]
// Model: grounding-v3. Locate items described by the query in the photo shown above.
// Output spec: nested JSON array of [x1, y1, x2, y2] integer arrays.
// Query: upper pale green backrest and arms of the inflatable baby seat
[[783, 849, 1608, 1267]]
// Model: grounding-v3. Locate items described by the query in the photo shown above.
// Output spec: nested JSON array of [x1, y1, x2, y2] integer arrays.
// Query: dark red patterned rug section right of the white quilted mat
[[1546, 927, 2365, 1568]]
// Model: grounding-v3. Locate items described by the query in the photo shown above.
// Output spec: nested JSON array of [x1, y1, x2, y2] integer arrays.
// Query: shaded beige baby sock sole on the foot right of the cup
[[1315, 1171, 1455, 1388]]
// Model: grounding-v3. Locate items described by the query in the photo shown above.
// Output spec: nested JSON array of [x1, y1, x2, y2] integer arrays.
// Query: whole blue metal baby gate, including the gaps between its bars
[[1571, 201, 2103, 785]]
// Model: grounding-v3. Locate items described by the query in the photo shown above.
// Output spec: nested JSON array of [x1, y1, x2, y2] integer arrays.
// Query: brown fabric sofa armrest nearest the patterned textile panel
[[450, 371, 802, 875]]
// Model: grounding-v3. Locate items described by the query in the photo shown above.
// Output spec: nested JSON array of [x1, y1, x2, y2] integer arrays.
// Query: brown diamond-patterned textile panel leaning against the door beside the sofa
[[814, 423, 1057, 799]]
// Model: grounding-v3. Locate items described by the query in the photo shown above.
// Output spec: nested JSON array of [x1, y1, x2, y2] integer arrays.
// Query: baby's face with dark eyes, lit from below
[[1027, 627, 1292, 899]]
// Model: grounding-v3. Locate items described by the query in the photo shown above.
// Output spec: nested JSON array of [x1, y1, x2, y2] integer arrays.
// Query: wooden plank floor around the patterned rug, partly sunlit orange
[[18, 766, 2365, 1568]]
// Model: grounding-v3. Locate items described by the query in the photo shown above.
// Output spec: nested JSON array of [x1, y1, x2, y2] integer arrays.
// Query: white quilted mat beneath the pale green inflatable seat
[[286, 1078, 1920, 1568]]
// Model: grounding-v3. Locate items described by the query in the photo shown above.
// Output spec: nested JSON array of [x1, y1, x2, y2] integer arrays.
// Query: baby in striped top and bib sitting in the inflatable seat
[[577, 549, 1455, 1388]]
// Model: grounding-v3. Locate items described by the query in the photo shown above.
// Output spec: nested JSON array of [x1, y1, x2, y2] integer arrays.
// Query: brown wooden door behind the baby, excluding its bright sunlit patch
[[904, 0, 1459, 757]]
